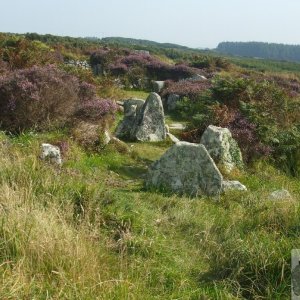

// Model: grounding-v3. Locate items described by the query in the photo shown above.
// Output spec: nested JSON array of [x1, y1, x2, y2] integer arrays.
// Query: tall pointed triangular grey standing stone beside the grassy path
[[131, 93, 167, 142]]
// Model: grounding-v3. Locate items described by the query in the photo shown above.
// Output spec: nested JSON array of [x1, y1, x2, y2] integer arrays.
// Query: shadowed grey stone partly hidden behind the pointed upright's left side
[[115, 99, 145, 139]]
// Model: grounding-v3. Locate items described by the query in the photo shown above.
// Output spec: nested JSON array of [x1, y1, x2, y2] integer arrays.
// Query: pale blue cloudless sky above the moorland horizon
[[0, 0, 300, 48]]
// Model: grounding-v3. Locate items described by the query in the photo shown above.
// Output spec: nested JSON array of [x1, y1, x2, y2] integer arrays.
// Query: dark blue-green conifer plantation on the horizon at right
[[216, 42, 300, 61]]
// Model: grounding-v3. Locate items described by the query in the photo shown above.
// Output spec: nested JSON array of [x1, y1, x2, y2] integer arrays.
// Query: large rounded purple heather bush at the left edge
[[0, 66, 115, 132]]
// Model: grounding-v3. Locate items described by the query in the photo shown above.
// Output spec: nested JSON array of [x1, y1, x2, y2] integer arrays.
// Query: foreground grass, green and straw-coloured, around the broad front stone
[[0, 132, 300, 299]]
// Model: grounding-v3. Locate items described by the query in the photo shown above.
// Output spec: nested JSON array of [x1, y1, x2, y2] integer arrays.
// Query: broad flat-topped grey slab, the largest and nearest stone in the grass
[[145, 142, 223, 196]]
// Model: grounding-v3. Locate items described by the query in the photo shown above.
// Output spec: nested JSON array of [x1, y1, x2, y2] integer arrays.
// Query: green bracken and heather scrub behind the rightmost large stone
[[178, 76, 300, 175]]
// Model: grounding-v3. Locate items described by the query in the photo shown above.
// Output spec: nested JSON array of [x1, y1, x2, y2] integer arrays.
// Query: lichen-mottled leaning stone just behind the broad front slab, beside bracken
[[200, 125, 243, 172]]
